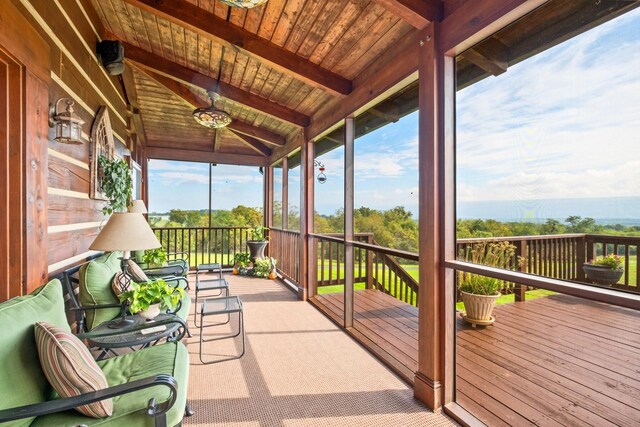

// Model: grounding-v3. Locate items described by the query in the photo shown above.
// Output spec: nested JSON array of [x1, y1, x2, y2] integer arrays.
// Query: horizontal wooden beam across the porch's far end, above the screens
[[147, 147, 267, 167]]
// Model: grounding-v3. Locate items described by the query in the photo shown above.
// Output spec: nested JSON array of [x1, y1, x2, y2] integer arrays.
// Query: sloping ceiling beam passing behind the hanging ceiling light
[[141, 69, 287, 145]]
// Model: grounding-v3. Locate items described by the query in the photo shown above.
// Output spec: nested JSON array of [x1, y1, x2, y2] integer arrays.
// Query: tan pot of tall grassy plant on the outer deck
[[458, 242, 515, 327]]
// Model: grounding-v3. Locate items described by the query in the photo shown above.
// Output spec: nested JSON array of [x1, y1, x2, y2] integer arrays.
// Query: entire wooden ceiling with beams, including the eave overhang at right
[[89, 0, 639, 165]]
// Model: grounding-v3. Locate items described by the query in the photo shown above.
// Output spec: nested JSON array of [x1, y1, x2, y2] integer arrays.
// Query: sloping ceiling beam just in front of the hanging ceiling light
[[122, 42, 309, 127]]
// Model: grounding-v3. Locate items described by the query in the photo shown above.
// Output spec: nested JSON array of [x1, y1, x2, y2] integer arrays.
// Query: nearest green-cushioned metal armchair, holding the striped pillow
[[0, 279, 189, 427]]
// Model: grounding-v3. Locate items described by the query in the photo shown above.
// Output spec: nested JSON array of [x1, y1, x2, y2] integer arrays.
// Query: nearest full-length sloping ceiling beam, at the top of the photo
[[124, 0, 351, 95]]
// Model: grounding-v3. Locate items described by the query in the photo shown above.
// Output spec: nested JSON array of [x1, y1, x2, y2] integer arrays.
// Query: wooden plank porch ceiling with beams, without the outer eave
[[92, 0, 420, 162]]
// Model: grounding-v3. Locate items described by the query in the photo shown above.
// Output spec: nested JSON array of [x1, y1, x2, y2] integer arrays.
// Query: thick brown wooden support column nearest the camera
[[414, 23, 455, 409]]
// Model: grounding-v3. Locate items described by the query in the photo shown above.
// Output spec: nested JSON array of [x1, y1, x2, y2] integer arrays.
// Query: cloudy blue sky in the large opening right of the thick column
[[457, 11, 640, 201]]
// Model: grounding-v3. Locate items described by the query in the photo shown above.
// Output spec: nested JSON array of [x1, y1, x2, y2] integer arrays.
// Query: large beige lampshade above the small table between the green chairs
[[89, 212, 161, 251]]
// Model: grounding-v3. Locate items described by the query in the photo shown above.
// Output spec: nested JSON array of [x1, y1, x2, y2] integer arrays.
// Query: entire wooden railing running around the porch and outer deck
[[154, 227, 640, 298]]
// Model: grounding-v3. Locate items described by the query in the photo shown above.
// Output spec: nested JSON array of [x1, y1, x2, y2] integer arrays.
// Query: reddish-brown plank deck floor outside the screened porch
[[313, 290, 640, 426]]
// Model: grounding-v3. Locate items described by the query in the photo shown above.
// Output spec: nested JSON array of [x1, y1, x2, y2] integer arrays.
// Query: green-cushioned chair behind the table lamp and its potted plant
[[64, 252, 191, 333]]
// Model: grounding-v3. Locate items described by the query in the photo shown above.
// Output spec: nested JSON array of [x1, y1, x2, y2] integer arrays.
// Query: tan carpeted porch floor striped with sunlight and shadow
[[184, 276, 454, 427]]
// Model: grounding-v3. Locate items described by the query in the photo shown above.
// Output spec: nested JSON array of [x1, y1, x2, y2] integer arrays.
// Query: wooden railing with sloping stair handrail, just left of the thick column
[[312, 233, 418, 305]]
